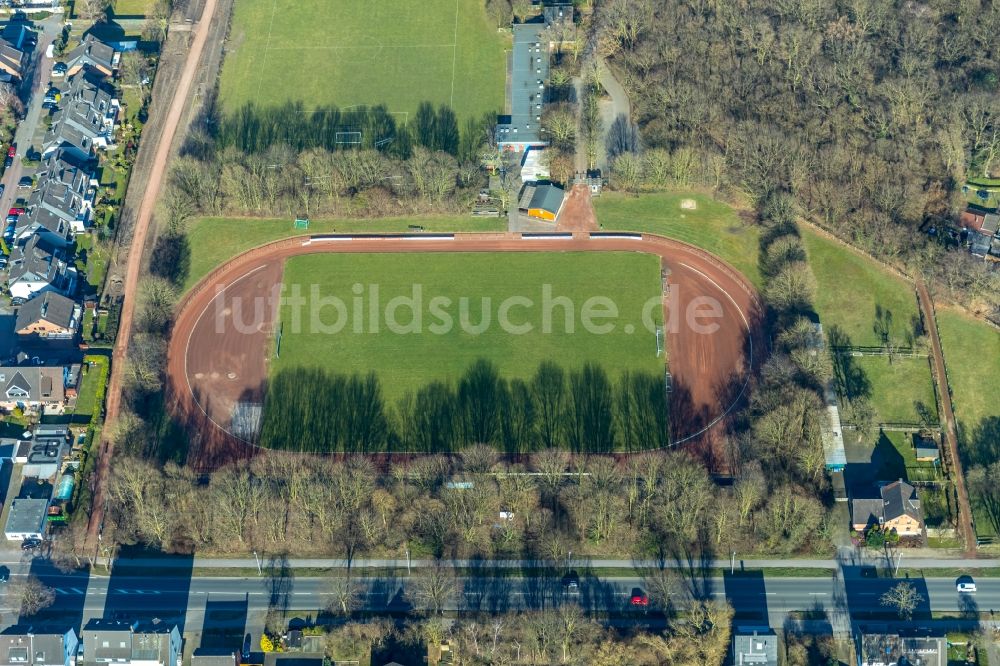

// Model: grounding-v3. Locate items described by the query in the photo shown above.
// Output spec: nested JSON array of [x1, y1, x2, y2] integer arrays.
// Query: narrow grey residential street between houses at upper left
[[0, 14, 63, 216]]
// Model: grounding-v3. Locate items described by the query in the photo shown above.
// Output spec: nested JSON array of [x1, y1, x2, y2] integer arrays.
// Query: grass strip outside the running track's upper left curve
[[184, 215, 507, 291]]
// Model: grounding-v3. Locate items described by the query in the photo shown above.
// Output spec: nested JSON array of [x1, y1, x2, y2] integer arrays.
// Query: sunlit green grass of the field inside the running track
[[271, 253, 663, 404]]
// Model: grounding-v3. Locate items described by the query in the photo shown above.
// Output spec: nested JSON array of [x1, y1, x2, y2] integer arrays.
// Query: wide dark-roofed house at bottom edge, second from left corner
[[80, 620, 183, 666]]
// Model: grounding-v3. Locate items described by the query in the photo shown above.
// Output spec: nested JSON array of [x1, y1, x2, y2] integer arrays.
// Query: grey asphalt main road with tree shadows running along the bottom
[[0, 571, 1000, 617]]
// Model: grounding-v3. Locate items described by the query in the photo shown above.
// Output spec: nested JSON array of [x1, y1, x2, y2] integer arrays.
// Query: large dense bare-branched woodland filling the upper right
[[598, 0, 1000, 320]]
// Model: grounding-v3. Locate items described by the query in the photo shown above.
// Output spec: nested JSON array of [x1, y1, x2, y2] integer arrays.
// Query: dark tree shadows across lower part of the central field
[[260, 360, 668, 454]]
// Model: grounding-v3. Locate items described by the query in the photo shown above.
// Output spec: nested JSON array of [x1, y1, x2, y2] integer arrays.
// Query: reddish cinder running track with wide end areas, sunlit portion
[[167, 233, 761, 469]]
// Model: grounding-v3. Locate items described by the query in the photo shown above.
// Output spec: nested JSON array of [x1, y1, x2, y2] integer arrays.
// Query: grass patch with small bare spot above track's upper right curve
[[594, 192, 761, 287]]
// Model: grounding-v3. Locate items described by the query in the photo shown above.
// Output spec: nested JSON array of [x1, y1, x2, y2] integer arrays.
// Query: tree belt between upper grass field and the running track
[[171, 103, 504, 217]]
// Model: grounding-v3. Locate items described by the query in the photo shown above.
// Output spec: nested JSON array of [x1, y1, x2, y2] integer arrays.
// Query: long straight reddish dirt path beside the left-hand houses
[[88, 0, 216, 539]]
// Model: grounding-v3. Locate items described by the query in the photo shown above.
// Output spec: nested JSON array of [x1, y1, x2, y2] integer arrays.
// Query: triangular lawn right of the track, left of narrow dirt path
[[800, 225, 919, 346]]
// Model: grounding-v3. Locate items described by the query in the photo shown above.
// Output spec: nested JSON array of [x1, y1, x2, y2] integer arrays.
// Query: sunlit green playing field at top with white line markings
[[220, 0, 508, 121]]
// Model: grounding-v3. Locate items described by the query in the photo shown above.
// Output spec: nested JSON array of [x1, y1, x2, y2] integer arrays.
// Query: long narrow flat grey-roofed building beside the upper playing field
[[497, 21, 549, 154]]
